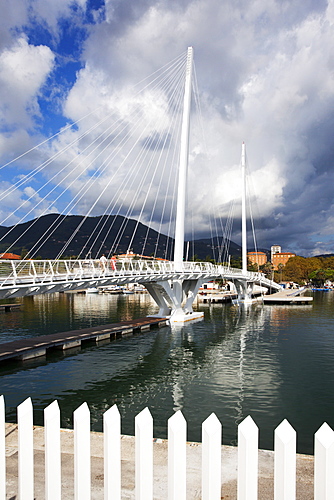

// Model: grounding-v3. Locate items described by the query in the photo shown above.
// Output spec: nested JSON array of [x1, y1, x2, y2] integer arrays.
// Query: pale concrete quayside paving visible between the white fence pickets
[[6, 424, 313, 500]]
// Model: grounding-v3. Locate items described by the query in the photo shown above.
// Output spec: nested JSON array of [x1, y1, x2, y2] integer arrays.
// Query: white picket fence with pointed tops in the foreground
[[0, 396, 334, 500]]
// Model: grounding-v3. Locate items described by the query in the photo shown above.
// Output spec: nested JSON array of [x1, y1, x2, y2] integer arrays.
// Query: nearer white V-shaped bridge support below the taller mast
[[145, 279, 205, 323]]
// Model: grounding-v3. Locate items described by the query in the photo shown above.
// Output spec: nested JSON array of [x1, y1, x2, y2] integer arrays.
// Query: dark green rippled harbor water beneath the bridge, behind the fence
[[0, 292, 334, 454]]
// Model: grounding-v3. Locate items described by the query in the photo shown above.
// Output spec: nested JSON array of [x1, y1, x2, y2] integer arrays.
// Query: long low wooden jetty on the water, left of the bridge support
[[0, 317, 168, 362]]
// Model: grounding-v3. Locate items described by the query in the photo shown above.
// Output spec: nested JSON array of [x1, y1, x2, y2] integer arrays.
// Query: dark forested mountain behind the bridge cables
[[0, 214, 241, 260]]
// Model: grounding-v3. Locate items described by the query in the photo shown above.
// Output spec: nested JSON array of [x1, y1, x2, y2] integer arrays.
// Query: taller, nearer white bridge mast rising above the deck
[[174, 47, 193, 271]]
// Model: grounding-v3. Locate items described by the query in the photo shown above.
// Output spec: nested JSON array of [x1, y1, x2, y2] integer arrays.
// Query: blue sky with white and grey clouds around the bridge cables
[[0, 0, 334, 256]]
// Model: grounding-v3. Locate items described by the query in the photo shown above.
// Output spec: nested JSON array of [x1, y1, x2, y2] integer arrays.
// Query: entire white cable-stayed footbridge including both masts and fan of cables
[[0, 47, 280, 321]]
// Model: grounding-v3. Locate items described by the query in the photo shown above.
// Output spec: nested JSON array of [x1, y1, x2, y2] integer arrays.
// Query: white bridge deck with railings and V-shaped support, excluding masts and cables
[[0, 259, 280, 315]]
